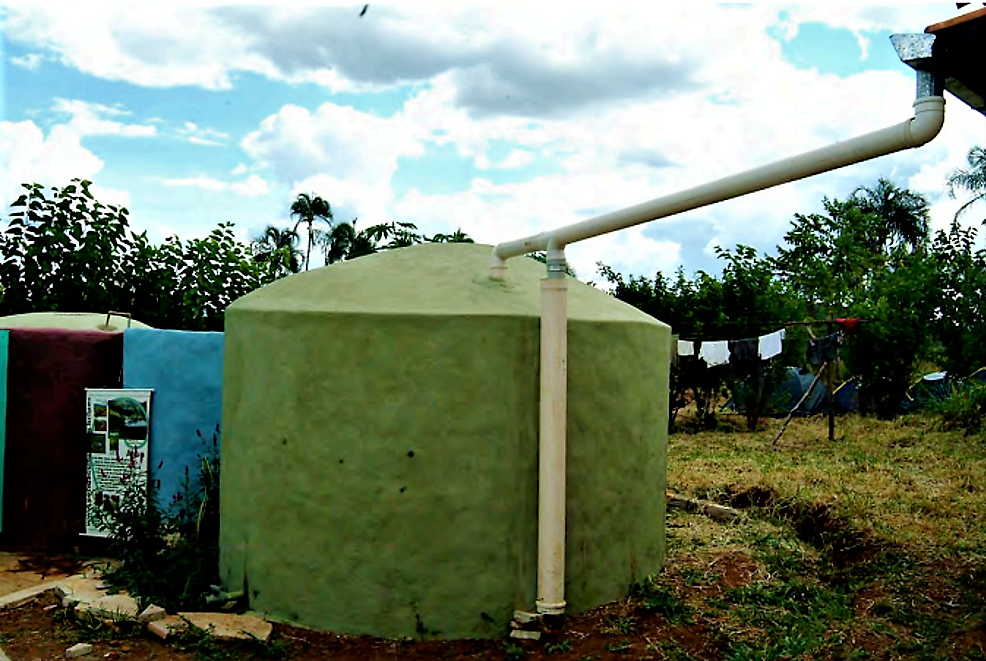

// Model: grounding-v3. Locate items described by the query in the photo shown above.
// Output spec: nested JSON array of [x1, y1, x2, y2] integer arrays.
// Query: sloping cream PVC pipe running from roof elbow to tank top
[[492, 96, 945, 266]]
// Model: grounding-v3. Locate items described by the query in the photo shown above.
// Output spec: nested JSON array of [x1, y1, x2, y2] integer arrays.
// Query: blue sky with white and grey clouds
[[0, 0, 986, 279]]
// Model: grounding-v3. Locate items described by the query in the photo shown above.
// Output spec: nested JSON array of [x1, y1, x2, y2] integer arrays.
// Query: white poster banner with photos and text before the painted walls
[[85, 388, 153, 537]]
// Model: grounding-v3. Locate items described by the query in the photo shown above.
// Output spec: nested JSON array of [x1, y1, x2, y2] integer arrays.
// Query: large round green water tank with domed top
[[220, 244, 671, 638]]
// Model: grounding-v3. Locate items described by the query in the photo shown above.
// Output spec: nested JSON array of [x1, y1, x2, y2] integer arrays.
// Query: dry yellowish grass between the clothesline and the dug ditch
[[668, 415, 986, 560]]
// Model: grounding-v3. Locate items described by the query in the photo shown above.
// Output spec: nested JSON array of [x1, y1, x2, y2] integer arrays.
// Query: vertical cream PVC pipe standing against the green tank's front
[[536, 242, 568, 615]]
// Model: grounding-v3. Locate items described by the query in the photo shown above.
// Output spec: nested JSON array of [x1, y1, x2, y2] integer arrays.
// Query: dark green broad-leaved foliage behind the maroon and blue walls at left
[[0, 179, 277, 330]]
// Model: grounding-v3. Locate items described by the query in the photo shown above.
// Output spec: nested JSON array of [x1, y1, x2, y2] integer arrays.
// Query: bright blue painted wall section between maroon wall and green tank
[[123, 328, 223, 507]]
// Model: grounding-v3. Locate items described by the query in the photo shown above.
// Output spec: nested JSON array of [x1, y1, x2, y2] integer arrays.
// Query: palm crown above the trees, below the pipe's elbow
[[851, 177, 931, 248]]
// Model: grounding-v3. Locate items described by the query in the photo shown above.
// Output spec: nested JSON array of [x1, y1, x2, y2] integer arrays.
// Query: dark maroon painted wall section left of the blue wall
[[0, 328, 123, 550]]
